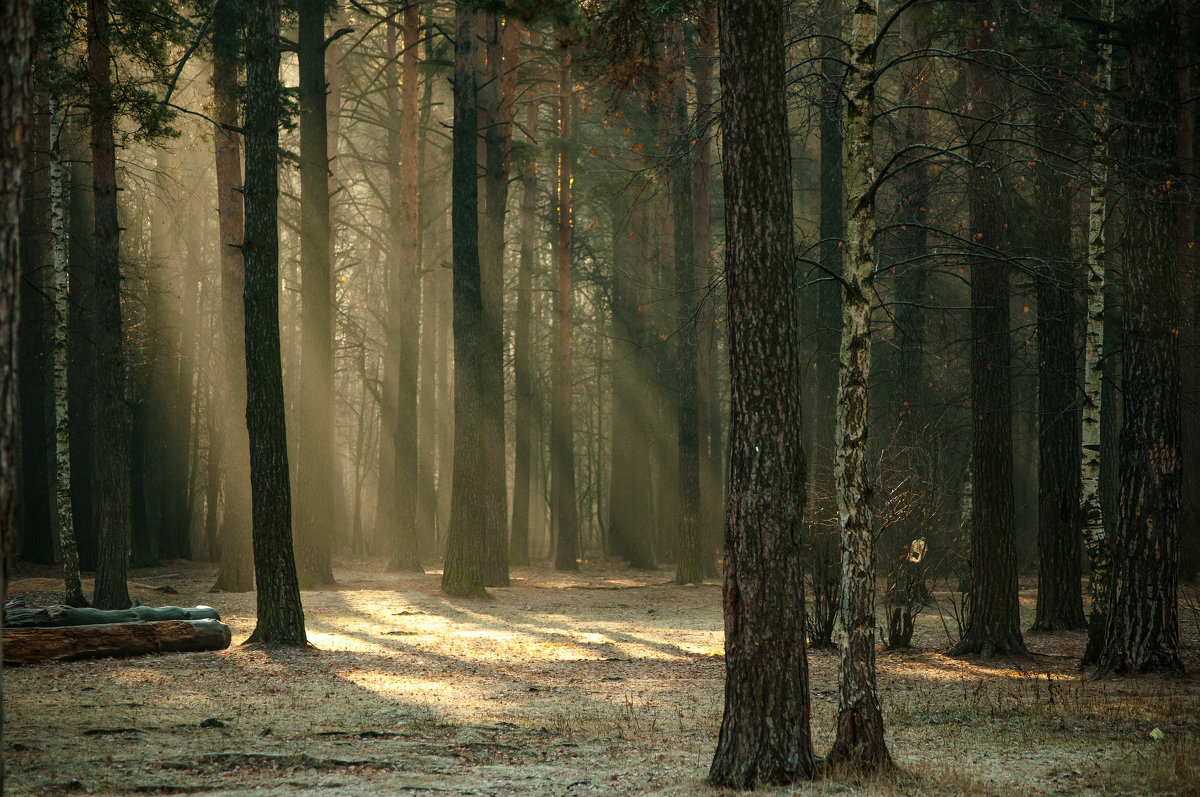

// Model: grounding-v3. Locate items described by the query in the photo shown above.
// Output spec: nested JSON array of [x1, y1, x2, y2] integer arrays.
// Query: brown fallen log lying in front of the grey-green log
[[4, 619, 229, 664]]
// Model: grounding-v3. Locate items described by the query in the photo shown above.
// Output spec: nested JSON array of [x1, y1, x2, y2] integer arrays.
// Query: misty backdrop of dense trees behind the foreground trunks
[[2, 0, 1200, 691]]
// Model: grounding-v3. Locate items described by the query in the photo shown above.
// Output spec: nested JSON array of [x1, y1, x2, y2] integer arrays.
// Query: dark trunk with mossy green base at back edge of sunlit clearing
[[442, 2, 493, 595]]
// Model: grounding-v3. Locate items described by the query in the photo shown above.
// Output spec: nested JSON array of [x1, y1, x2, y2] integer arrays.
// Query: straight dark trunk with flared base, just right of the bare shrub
[[949, 14, 1027, 659]]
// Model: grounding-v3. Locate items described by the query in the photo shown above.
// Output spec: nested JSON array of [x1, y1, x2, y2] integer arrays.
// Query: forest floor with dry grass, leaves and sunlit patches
[[4, 562, 1200, 797]]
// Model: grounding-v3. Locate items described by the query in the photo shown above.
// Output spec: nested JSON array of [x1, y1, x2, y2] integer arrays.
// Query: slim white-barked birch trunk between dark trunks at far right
[[1080, 0, 1114, 666]]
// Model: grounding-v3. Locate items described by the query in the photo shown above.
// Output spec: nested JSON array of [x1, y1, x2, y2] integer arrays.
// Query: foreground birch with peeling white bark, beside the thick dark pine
[[828, 0, 892, 772]]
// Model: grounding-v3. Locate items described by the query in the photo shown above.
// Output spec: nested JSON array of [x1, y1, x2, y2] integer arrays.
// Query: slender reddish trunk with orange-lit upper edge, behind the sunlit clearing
[[550, 24, 580, 570]]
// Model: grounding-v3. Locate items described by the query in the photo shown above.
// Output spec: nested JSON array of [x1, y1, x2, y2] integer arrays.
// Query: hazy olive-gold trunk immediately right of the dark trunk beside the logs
[[293, 0, 335, 586]]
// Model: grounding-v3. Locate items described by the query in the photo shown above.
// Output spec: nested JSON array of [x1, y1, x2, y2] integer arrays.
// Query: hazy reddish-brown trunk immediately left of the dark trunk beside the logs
[[209, 2, 254, 592]]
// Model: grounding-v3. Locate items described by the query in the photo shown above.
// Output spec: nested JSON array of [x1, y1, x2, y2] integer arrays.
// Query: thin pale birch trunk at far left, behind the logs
[[46, 10, 88, 606]]
